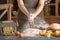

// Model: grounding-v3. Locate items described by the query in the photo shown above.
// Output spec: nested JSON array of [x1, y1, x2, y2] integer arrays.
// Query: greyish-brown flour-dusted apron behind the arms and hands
[[18, 0, 49, 32]]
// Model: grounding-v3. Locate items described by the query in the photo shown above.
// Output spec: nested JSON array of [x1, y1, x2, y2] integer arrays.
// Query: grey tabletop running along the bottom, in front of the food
[[0, 36, 60, 40]]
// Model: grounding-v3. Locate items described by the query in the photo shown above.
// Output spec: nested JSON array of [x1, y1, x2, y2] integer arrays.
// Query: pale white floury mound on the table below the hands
[[23, 28, 41, 37]]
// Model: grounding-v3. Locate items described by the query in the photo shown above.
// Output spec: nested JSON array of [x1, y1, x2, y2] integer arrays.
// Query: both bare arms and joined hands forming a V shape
[[17, 0, 45, 22]]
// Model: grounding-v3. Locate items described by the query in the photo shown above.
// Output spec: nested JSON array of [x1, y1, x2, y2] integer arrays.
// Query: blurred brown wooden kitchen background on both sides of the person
[[0, 0, 60, 24]]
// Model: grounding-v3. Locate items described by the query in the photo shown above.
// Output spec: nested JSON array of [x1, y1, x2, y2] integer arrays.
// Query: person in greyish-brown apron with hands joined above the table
[[17, 0, 49, 36]]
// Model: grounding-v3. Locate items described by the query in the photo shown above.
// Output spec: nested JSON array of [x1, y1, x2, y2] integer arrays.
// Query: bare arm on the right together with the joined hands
[[28, 0, 45, 23]]
